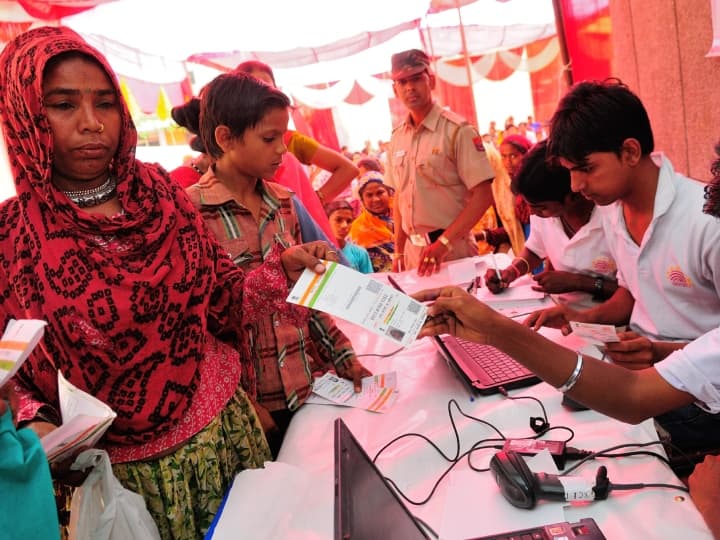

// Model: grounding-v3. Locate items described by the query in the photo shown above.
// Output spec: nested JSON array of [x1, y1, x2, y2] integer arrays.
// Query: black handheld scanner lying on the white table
[[490, 451, 610, 509]]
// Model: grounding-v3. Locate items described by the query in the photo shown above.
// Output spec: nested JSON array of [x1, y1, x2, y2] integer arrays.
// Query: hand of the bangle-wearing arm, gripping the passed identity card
[[412, 287, 503, 343]]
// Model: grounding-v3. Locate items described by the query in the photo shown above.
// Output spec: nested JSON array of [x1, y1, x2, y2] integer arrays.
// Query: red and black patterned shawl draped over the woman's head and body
[[0, 27, 295, 462]]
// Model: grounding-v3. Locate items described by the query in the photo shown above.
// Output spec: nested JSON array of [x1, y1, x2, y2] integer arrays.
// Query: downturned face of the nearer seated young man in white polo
[[560, 152, 633, 206]]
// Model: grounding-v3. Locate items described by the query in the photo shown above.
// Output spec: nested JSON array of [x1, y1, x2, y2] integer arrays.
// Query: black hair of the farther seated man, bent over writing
[[510, 140, 572, 204]]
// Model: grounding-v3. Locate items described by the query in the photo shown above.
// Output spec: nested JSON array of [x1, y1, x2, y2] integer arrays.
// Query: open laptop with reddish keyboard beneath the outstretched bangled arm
[[434, 335, 540, 395]]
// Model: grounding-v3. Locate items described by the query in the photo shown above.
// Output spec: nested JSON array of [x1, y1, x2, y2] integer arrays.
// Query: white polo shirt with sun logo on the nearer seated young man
[[602, 155, 720, 340]]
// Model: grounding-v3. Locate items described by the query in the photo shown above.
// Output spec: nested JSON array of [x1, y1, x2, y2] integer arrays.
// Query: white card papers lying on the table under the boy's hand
[[306, 371, 397, 412]]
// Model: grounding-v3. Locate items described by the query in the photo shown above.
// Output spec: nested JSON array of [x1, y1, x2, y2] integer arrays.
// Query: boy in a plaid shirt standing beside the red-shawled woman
[[187, 73, 369, 456]]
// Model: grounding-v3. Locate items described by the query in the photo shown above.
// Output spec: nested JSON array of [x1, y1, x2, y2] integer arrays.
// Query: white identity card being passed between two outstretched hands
[[287, 261, 427, 347]]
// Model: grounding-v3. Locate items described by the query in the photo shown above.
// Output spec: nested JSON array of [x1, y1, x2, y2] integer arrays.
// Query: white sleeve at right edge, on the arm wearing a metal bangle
[[655, 328, 720, 413]]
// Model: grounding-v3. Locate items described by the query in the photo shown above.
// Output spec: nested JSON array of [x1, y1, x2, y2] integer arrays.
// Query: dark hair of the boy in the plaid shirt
[[200, 72, 290, 159]]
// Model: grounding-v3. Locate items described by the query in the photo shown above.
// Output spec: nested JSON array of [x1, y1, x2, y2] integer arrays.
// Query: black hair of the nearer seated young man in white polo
[[548, 79, 655, 164]]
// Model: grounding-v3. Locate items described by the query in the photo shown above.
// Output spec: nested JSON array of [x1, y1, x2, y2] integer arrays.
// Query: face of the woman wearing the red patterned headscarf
[[43, 57, 121, 189]]
